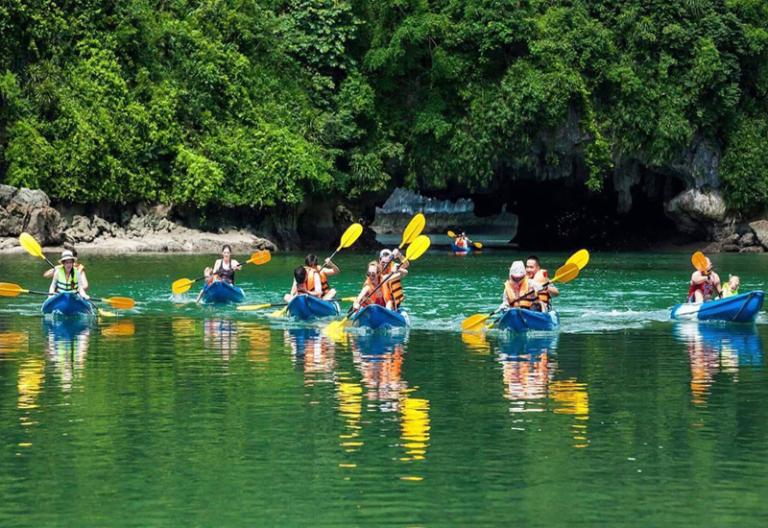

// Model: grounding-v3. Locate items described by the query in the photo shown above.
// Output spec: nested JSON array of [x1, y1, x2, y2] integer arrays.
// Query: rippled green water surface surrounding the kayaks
[[0, 251, 768, 526]]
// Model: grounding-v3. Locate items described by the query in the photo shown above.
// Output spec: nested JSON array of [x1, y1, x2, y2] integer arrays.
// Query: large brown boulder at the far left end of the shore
[[0, 185, 62, 245]]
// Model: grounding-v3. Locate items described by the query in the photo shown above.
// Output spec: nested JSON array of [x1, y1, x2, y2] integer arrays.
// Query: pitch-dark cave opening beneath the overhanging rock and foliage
[[473, 173, 691, 250]]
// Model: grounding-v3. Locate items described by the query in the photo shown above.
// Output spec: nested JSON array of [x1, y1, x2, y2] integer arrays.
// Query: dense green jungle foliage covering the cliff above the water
[[0, 0, 768, 213]]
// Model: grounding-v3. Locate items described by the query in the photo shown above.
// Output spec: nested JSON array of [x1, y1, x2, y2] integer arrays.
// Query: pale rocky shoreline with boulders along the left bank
[[0, 185, 277, 254]]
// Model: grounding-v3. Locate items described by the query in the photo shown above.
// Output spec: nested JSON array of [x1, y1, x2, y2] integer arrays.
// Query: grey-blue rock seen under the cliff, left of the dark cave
[[371, 188, 517, 240]]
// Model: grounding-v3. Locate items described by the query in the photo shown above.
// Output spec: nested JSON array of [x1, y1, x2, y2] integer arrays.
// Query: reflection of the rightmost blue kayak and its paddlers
[[674, 322, 763, 405]]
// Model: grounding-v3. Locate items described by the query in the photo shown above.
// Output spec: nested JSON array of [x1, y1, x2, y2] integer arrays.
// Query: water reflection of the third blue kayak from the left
[[283, 328, 336, 385]]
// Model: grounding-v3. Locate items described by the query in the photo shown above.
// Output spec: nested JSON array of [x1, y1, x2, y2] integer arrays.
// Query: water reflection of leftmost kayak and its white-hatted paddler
[[43, 317, 95, 391]]
